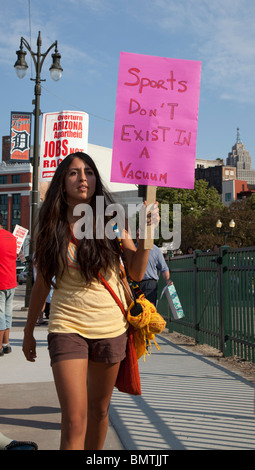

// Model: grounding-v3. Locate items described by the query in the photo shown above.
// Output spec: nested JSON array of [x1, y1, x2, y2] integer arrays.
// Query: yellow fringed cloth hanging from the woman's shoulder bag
[[127, 295, 166, 361]]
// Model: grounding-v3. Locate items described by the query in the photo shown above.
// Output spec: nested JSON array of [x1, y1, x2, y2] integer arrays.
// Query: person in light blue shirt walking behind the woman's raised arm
[[136, 230, 170, 305]]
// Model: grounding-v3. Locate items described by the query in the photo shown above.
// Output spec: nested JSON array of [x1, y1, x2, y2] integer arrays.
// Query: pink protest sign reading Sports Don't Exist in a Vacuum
[[111, 52, 201, 189]]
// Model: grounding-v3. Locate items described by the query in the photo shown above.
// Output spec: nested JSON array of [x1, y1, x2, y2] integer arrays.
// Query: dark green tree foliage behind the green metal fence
[[156, 180, 255, 253]]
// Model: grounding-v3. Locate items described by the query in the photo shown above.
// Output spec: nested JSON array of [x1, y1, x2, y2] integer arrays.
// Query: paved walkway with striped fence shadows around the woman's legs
[[0, 286, 255, 451]]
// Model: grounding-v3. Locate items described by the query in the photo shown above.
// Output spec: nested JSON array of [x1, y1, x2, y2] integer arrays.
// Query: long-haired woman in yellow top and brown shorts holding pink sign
[[23, 152, 159, 450]]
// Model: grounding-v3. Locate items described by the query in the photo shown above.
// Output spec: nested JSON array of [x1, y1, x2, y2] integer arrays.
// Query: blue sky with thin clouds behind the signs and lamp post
[[0, 0, 255, 168]]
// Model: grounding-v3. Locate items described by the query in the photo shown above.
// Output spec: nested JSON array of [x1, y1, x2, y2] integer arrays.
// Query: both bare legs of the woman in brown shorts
[[52, 359, 119, 450]]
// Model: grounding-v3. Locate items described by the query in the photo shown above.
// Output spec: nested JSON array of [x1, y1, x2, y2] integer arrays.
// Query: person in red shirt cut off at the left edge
[[0, 213, 17, 356]]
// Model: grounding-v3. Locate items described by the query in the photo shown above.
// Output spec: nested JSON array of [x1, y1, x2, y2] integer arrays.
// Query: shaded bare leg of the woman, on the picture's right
[[85, 361, 120, 450]]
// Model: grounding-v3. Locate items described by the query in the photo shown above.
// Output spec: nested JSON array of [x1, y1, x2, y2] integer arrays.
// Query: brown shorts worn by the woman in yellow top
[[48, 332, 127, 365]]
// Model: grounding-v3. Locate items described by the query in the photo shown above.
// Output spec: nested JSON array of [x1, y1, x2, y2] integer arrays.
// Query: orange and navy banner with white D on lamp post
[[10, 112, 32, 162]]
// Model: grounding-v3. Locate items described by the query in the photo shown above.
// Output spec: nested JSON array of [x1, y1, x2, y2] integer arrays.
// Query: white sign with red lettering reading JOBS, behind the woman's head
[[39, 111, 89, 181]]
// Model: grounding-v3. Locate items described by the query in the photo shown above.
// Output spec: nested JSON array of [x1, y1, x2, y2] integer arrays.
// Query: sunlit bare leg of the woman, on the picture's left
[[52, 359, 88, 450]]
